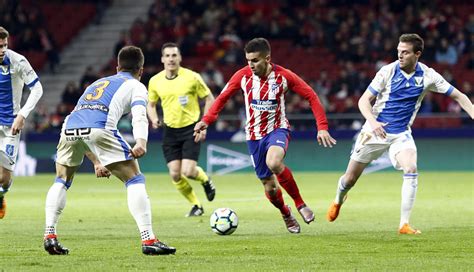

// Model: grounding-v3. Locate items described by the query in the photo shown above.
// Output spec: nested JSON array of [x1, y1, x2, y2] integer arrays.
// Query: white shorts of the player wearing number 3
[[56, 128, 133, 167]]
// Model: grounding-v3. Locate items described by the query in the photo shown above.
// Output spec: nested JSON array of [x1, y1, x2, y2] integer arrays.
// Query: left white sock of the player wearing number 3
[[44, 182, 67, 236]]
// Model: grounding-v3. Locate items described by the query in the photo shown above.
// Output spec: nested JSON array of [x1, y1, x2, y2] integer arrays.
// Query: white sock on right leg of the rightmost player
[[400, 173, 418, 228]]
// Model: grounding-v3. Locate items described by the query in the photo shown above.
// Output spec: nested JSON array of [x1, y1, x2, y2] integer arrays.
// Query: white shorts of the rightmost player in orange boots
[[351, 131, 416, 170]]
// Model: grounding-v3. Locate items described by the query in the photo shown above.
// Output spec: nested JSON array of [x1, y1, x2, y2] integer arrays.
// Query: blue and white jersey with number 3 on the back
[[64, 72, 148, 130]]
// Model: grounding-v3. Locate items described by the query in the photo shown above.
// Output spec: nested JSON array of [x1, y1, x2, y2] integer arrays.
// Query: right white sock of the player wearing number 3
[[127, 183, 155, 241]]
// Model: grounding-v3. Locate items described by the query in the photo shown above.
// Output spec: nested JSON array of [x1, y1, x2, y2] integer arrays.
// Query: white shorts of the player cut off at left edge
[[0, 126, 20, 171]]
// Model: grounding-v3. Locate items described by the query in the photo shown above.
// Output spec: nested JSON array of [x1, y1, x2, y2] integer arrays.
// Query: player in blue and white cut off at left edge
[[0, 26, 43, 219]]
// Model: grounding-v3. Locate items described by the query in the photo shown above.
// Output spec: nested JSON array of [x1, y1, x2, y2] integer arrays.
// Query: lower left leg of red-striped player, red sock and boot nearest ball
[[260, 174, 301, 233]]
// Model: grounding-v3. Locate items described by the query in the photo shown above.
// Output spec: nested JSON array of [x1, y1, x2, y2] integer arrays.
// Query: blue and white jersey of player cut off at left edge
[[0, 49, 42, 126]]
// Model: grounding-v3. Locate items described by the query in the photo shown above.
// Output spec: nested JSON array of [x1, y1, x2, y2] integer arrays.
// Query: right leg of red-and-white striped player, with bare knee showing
[[265, 129, 314, 224]]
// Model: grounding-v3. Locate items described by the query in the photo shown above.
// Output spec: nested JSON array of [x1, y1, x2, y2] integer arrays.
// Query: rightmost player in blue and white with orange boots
[[327, 34, 474, 234]]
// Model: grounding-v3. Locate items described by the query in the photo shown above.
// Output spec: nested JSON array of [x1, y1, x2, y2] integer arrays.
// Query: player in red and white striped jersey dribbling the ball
[[194, 38, 336, 233]]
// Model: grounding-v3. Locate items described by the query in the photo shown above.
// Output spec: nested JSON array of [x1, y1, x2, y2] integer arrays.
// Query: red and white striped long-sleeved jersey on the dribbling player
[[202, 64, 328, 140]]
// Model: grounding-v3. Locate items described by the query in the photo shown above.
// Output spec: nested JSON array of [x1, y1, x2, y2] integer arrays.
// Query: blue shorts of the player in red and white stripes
[[247, 128, 290, 179]]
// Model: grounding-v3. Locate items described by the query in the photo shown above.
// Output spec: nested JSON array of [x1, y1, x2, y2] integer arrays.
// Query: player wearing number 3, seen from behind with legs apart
[[44, 46, 176, 255]]
